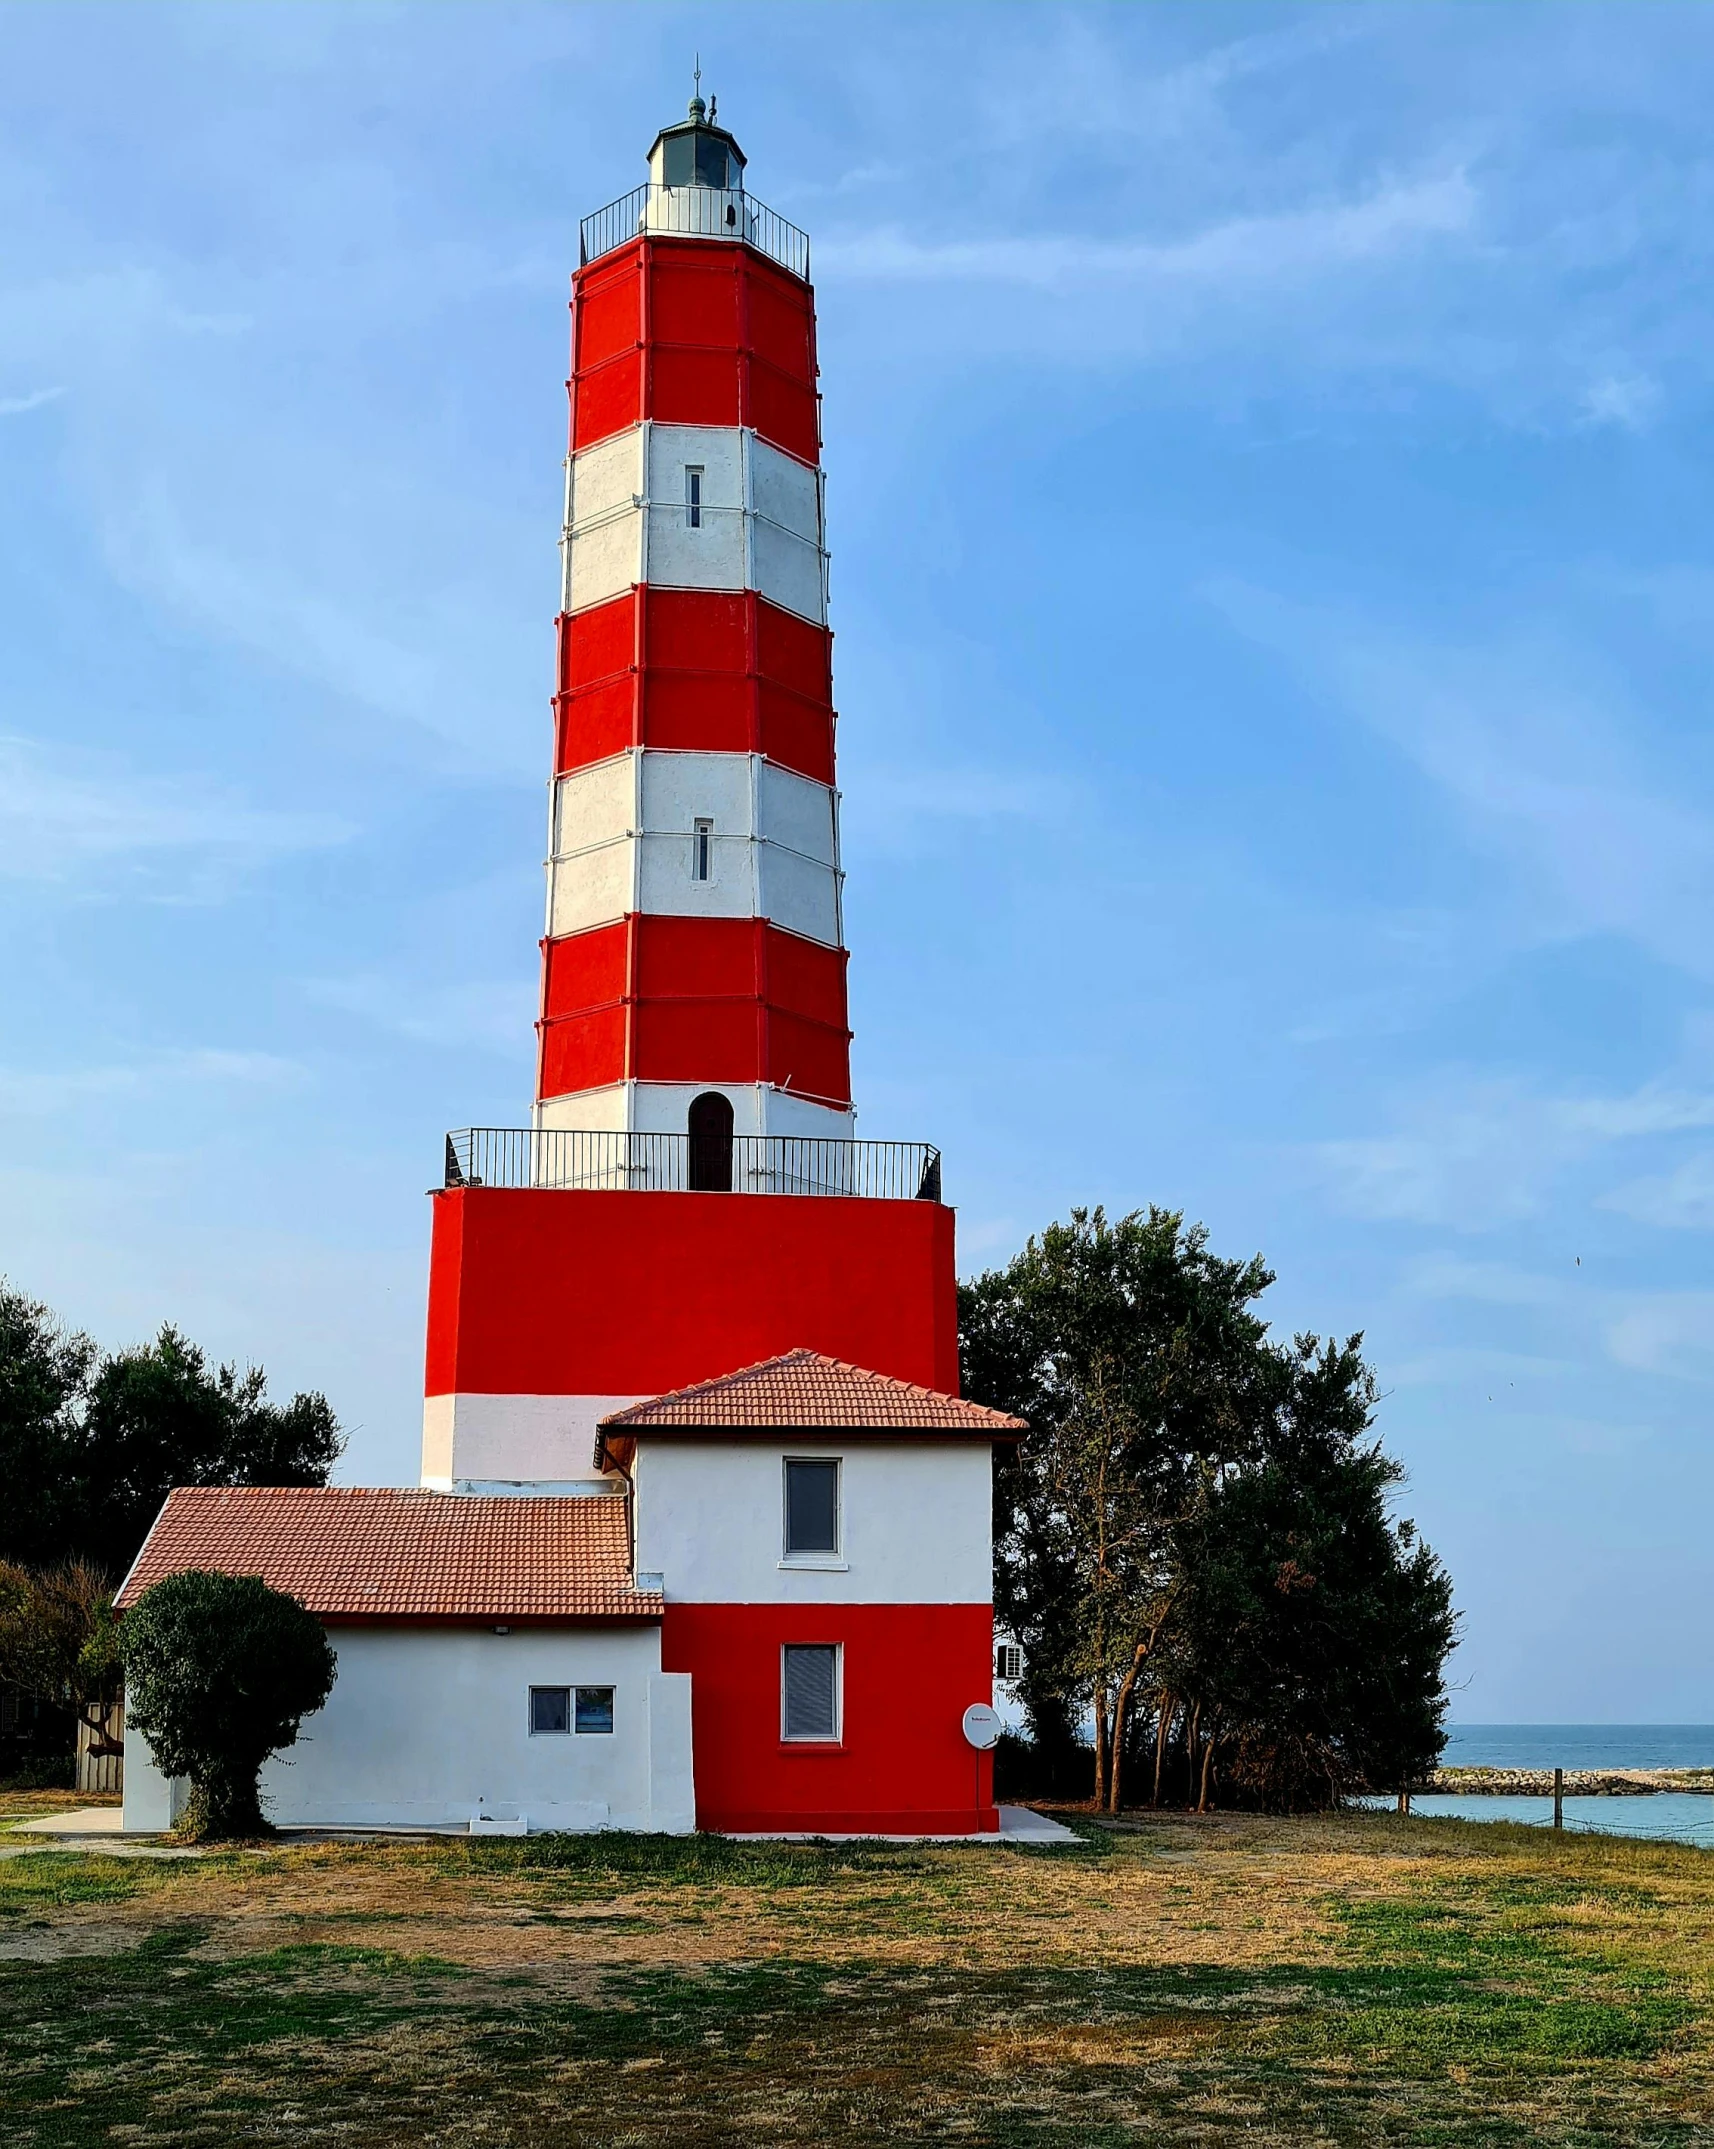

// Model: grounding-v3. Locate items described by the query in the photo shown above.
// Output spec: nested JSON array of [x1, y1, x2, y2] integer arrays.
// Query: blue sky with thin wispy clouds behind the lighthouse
[[0, 4, 1714, 1721]]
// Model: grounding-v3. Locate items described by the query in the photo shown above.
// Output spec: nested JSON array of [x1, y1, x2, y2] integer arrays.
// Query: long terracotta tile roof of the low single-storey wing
[[118, 1485, 662, 1620]]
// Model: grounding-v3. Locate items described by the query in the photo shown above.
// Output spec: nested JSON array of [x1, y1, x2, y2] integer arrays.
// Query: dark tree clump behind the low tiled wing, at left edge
[[0, 1281, 344, 1577]]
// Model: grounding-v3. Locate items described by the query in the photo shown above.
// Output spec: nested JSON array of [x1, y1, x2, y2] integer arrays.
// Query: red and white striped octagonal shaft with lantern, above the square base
[[535, 97, 853, 1141]]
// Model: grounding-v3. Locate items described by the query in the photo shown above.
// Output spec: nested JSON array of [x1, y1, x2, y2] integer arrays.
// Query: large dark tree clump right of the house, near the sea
[[960, 1208, 1454, 1809]]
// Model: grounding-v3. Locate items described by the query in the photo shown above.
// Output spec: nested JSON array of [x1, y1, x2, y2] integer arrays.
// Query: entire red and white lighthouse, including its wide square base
[[423, 97, 958, 1489]]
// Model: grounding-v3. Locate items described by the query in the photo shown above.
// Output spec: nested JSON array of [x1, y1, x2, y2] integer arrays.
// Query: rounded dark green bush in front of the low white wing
[[120, 1569, 337, 1840]]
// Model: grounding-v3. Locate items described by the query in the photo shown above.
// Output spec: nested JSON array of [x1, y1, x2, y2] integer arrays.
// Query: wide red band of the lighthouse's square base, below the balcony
[[423, 1186, 958, 1395]]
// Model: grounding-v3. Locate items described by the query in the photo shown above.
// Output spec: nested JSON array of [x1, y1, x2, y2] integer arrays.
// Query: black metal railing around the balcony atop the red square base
[[445, 1126, 941, 1201]]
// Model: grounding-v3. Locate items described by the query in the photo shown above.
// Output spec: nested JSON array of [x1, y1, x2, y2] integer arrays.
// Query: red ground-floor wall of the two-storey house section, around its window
[[662, 1603, 999, 1835]]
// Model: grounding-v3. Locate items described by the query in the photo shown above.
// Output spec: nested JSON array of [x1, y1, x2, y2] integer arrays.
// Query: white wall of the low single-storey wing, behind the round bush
[[125, 1625, 696, 1835]]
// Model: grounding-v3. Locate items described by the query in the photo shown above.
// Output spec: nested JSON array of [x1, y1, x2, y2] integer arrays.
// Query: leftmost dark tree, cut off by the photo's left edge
[[0, 1279, 97, 1567]]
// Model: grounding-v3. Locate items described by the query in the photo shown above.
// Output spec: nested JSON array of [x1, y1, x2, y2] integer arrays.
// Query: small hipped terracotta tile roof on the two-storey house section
[[601, 1350, 1029, 1440]]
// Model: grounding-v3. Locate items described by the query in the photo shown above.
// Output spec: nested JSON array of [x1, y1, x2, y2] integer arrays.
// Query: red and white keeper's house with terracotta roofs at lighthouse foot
[[120, 1350, 1035, 1833]]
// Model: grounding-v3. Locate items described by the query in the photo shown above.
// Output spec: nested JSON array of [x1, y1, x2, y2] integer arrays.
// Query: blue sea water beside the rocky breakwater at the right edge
[[1375, 1723, 1714, 1848]]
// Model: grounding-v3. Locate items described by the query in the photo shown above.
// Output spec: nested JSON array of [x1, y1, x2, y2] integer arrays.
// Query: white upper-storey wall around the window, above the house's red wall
[[634, 1436, 994, 1605]]
